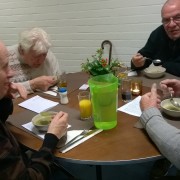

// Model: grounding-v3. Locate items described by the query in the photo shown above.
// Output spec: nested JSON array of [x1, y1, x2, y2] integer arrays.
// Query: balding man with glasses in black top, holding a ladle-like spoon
[[131, 0, 180, 76]]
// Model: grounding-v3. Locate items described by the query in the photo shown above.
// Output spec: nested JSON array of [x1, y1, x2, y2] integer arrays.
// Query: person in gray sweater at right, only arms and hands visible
[[140, 79, 180, 179]]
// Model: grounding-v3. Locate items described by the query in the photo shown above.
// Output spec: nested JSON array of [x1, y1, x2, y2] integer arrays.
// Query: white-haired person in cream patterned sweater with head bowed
[[7, 28, 61, 93]]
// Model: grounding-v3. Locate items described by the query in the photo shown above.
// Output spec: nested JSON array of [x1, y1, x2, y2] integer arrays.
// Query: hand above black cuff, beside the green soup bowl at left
[[47, 111, 68, 139]]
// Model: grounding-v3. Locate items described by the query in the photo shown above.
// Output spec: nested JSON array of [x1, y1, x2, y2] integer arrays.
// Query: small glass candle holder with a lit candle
[[131, 79, 142, 96]]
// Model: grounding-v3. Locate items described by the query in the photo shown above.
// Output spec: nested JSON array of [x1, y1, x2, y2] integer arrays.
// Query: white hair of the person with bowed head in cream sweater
[[19, 28, 51, 54]]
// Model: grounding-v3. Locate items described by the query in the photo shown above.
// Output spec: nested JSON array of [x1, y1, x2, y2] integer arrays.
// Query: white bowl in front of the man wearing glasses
[[144, 66, 166, 78]]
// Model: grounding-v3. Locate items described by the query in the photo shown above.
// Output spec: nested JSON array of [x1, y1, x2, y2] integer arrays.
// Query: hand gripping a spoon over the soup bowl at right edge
[[160, 79, 180, 96]]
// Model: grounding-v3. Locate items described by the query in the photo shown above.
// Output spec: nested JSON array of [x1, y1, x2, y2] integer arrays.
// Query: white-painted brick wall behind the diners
[[0, 0, 165, 72]]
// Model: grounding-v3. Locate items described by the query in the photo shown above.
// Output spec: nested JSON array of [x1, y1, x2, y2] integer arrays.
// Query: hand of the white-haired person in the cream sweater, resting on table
[[30, 76, 57, 91]]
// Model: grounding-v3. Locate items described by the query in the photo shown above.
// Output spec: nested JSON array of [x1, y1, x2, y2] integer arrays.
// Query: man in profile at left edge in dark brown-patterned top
[[0, 42, 68, 180]]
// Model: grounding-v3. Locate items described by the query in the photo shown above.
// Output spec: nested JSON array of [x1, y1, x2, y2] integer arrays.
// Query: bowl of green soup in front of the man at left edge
[[32, 111, 57, 131]]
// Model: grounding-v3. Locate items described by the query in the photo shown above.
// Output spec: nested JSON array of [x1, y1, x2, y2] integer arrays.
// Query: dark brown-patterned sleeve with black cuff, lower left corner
[[0, 125, 59, 180]]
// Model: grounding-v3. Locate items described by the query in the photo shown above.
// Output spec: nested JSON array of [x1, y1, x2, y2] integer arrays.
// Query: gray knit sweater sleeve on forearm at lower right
[[140, 108, 180, 169]]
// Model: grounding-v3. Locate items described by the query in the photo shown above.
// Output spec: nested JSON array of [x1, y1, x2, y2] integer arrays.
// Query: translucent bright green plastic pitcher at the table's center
[[88, 74, 118, 130]]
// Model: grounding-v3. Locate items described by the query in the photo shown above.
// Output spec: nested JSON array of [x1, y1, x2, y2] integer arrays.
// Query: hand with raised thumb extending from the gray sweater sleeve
[[140, 84, 161, 111]]
